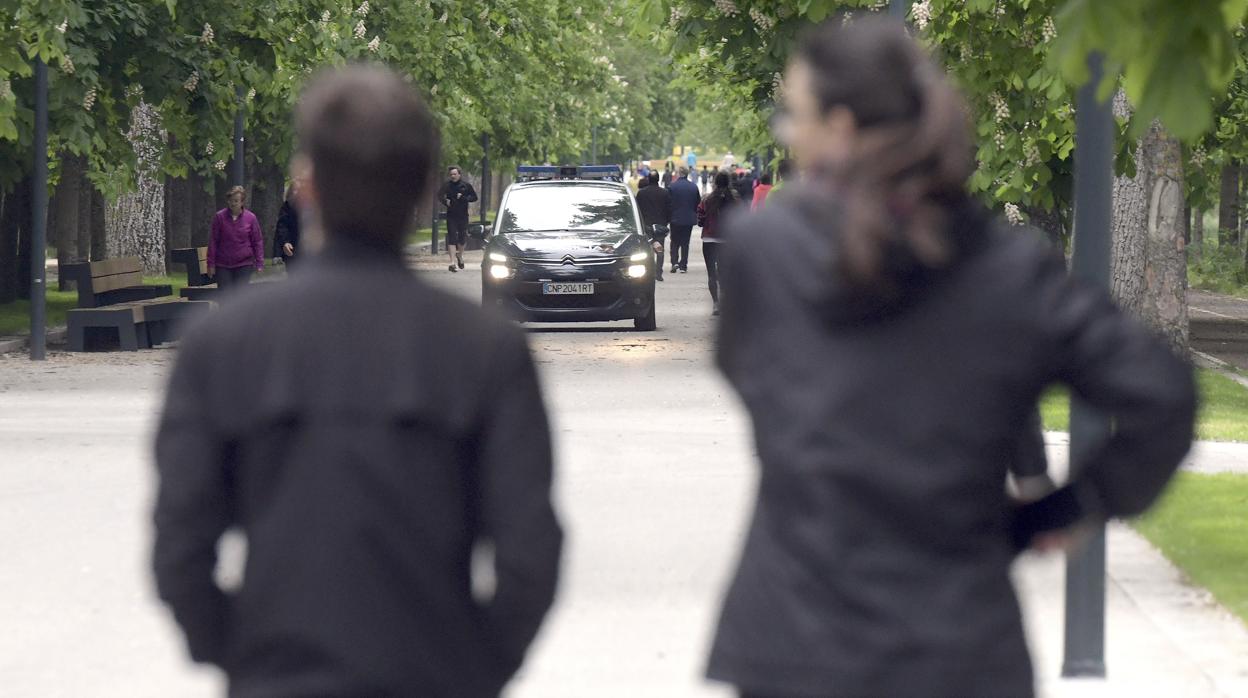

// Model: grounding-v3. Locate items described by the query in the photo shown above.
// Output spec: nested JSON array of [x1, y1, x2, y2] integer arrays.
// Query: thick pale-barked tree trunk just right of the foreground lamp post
[[1112, 117, 1188, 355]]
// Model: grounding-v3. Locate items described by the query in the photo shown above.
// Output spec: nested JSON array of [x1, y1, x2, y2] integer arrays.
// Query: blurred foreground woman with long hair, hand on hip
[[706, 19, 1196, 698]]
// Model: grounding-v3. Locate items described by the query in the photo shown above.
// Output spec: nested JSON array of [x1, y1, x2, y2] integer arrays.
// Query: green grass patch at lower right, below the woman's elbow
[[1133, 473, 1248, 622]]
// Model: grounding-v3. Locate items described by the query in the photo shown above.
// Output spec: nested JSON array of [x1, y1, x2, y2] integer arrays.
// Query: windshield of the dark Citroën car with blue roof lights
[[498, 185, 636, 233]]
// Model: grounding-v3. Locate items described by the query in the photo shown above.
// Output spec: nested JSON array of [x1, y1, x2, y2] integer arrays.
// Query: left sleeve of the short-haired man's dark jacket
[[152, 336, 233, 664]]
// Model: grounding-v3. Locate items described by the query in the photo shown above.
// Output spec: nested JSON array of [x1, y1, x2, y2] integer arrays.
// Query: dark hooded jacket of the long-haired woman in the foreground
[[708, 198, 1194, 698]]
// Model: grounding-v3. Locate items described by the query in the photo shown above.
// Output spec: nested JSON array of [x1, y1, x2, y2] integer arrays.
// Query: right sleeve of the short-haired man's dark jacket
[[478, 328, 563, 676]]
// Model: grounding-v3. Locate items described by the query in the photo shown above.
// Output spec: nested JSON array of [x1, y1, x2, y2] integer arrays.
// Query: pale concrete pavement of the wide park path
[[0, 248, 1248, 698]]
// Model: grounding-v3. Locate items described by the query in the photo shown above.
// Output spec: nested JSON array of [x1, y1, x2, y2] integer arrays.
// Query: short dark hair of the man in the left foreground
[[296, 65, 441, 253]]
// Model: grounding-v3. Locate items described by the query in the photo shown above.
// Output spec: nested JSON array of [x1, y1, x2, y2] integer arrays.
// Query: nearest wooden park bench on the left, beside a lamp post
[[62, 257, 211, 351]]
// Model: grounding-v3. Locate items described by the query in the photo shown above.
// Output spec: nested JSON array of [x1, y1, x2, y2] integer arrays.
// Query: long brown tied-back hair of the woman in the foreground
[[796, 17, 973, 295]]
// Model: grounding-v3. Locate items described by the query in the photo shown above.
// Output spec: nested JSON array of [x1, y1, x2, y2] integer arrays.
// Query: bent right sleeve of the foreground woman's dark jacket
[[1037, 248, 1196, 516]]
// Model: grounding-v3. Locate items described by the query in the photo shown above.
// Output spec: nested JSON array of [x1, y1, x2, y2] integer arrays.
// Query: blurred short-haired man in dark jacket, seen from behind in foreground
[[152, 66, 562, 698]]
